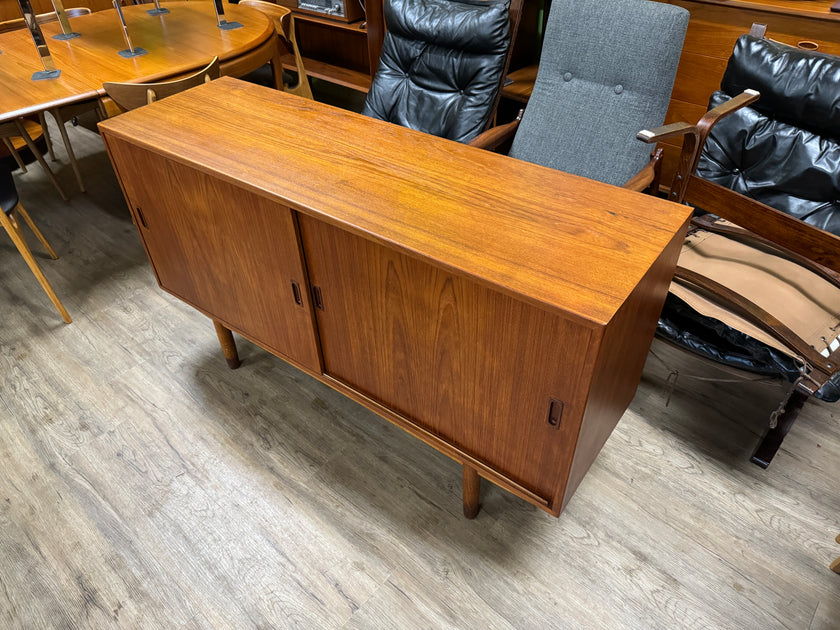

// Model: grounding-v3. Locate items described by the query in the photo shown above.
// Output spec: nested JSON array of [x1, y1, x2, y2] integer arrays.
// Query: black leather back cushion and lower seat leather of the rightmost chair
[[657, 35, 840, 401]]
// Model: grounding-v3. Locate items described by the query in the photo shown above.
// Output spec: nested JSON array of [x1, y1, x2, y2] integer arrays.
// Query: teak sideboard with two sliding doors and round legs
[[100, 78, 690, 516]]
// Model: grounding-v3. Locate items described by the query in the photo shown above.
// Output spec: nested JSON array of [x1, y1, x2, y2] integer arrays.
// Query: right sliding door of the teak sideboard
[[300, 217, 592, 499]]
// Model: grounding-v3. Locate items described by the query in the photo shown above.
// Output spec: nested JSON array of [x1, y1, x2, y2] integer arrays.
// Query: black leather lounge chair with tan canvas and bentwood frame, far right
[[643, 29, 840, 468]]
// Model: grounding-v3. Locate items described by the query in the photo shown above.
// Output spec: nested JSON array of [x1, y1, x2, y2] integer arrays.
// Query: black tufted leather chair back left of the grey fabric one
[[362, 0, 510, 142]]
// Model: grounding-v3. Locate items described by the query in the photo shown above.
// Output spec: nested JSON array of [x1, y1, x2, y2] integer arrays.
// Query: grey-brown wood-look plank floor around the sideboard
[[0, 119, 840, 630]]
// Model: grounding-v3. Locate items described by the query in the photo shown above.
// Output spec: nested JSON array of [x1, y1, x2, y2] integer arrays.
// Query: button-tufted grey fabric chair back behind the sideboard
[[510, 0, 688, 186]]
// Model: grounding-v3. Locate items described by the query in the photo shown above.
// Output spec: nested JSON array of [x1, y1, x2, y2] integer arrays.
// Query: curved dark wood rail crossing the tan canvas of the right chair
[[674, 265, 840, 393]]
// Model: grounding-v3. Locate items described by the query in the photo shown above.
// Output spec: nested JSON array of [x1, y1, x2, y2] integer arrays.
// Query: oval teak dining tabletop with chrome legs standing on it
[[0, 1, 282, 123]]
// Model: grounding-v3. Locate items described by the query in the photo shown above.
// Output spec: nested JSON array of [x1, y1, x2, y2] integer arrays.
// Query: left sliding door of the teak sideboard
[[99, 140, 321, 372]]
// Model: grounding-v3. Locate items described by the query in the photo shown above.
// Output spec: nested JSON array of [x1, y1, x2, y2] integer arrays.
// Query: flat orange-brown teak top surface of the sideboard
[[100, 77, 690, 325]]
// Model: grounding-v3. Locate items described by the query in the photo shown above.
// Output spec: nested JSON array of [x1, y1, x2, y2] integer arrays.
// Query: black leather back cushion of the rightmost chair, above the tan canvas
[[697, 35, 840, 236]]
